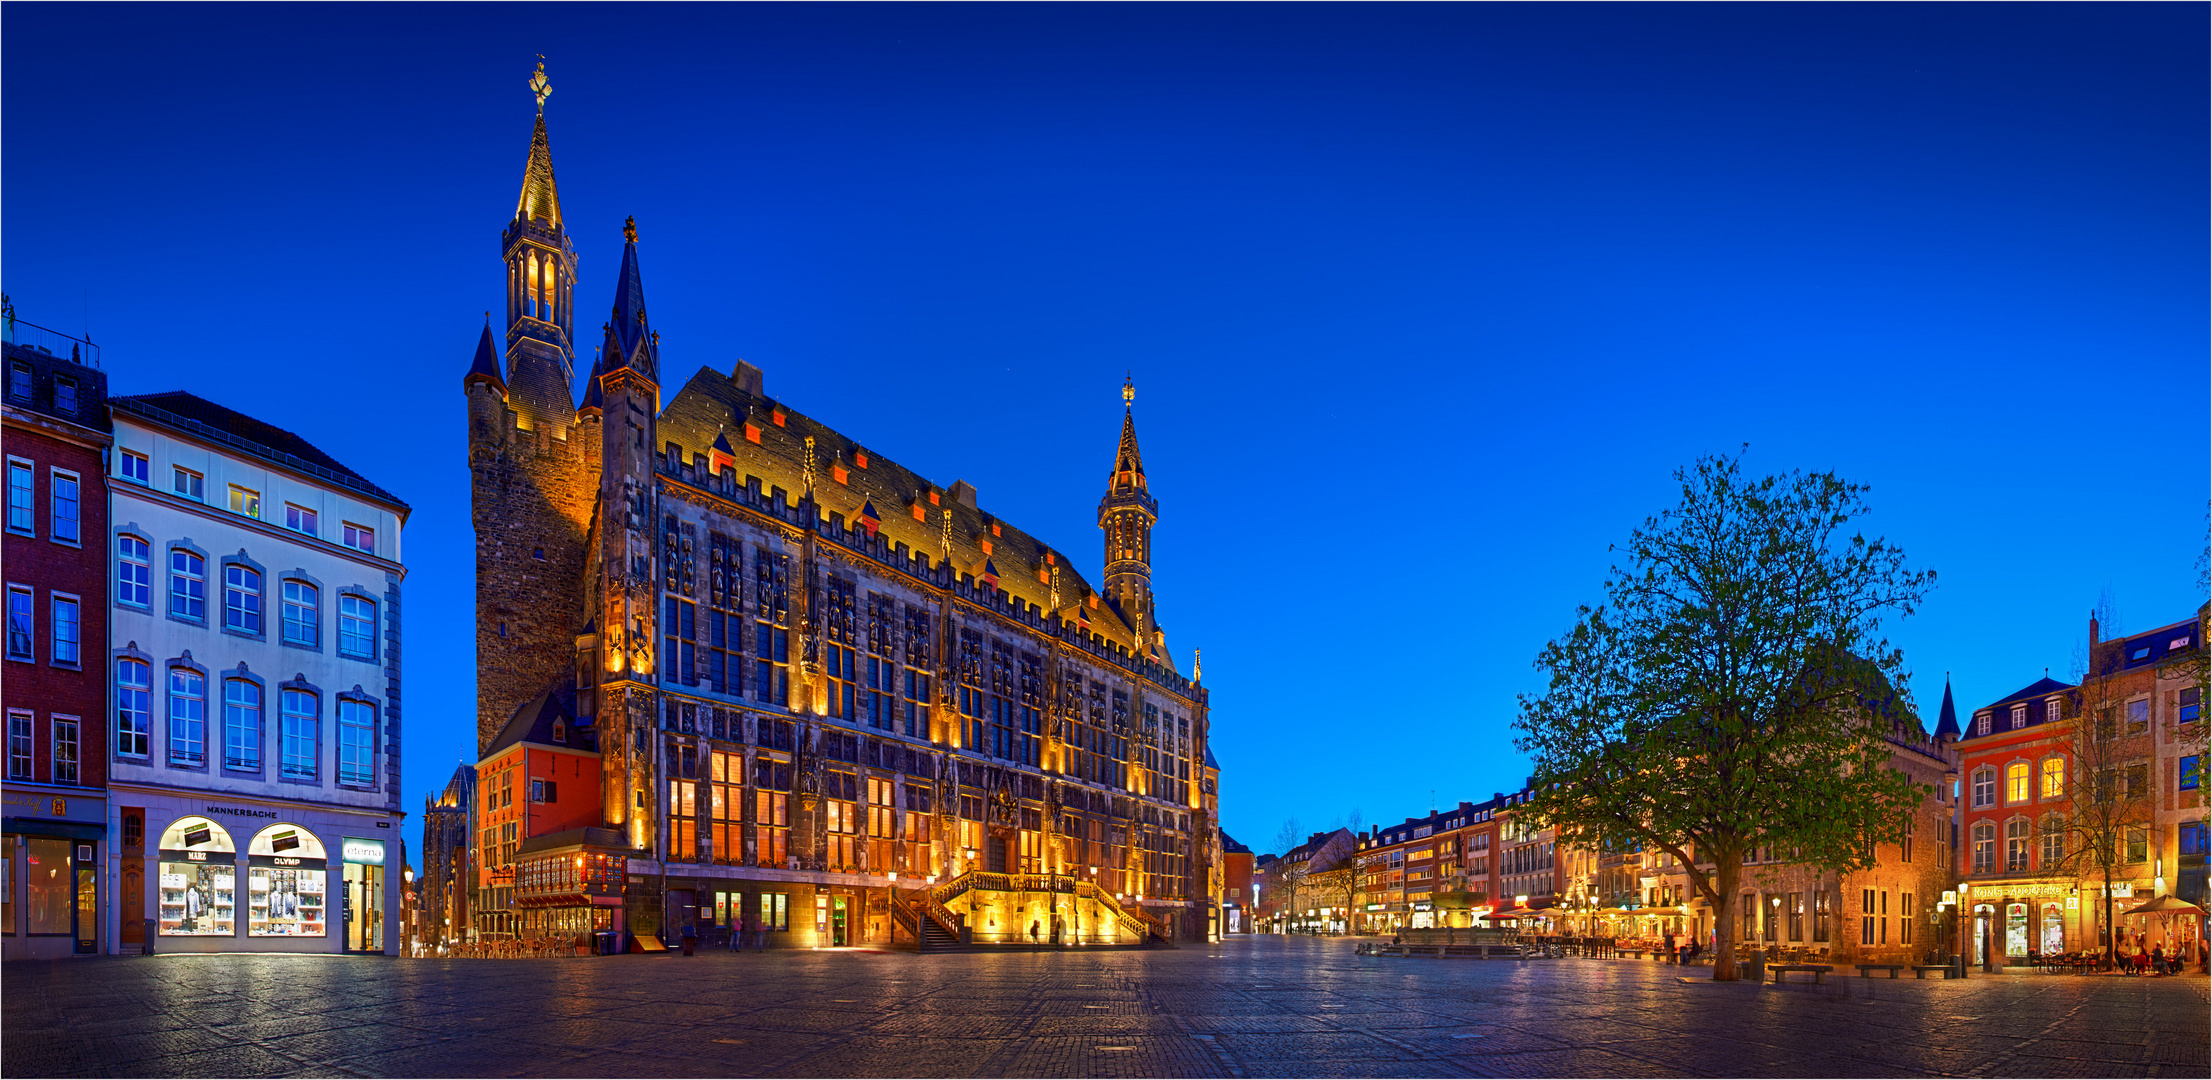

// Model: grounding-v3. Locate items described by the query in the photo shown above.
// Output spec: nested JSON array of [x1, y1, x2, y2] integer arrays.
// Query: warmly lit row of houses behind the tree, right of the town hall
[[1239, 609, 2205, 965]]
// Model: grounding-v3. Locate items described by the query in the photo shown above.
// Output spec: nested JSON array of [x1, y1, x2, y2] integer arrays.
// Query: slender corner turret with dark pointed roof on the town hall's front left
[[577, 219, 659, 848]]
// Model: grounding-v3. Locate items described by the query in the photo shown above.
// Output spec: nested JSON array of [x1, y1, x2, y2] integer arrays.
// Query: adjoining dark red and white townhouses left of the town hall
[[0, 308, 409, 960]]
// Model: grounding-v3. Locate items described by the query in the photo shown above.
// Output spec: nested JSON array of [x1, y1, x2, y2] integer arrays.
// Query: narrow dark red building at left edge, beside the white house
[[0, 316, 115, 960]]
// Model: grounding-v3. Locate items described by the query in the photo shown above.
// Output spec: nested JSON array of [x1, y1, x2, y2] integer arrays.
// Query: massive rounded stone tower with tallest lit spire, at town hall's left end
[[462, 56, 599, 750]]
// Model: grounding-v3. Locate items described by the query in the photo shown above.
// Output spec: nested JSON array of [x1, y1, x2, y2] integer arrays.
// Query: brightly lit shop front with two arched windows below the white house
[[124, 801, 396, 954]]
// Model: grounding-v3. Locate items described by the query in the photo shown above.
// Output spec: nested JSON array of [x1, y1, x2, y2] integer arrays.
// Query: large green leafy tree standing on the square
[[1513, 456, 1936, 980]]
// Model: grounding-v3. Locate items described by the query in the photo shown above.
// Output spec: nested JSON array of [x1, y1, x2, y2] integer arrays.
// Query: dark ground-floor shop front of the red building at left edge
[[0, 790, 108, 960]]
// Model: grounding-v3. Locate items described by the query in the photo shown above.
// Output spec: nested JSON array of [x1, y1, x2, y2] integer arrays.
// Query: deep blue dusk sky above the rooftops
[[0, 4, 2208, 850]]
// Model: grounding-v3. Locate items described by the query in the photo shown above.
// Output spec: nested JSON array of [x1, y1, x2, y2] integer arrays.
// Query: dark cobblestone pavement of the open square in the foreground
[[0, 936, 2212, 1078]]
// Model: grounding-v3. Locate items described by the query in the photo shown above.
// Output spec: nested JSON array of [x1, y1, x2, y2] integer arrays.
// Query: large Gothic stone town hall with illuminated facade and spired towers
[[462, 69, 1219, 945]]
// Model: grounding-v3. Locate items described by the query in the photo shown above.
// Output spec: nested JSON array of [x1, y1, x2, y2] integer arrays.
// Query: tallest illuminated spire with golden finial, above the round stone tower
[[500, 60, 575, 429]]
